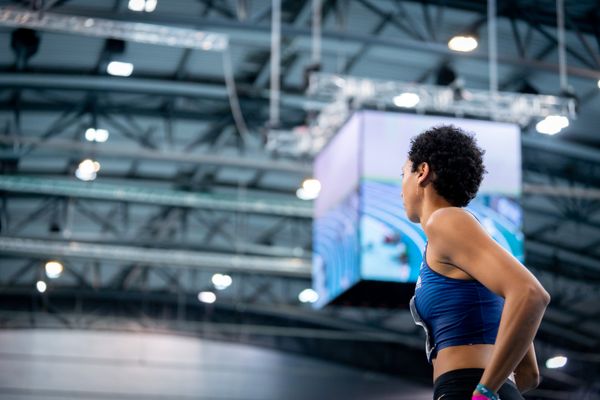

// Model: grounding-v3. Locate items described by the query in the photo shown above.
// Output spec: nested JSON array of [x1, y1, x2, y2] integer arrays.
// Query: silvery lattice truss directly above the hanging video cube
[[302, 73, 576, 155]]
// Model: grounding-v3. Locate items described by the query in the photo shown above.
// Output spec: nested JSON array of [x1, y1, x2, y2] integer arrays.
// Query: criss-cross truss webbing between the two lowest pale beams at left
[[2, 192, 311, 259]]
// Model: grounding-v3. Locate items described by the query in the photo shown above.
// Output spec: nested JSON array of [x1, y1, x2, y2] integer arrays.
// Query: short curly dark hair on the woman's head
[[408, 125, 487, 207]]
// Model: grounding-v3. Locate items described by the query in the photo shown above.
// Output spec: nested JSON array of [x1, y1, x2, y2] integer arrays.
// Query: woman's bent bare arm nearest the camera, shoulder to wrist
[[426, 208, 550, 392]]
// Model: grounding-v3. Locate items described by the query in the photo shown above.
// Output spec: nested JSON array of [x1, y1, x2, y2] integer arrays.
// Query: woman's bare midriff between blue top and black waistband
[[432, 344, 494, 382]]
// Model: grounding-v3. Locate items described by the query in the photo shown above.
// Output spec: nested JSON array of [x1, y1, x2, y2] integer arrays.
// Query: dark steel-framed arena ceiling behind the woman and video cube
[[0, 0, 600, 398]]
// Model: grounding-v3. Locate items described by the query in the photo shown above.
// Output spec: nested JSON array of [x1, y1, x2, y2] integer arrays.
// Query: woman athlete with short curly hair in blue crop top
[[402, 126, 550, 400]]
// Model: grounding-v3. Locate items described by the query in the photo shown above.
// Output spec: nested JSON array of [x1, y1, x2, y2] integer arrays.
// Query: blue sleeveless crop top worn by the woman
[[410, 242, 504, 363]]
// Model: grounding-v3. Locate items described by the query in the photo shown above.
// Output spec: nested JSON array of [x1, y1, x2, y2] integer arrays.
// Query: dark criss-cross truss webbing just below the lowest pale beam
[[0, 254, 310, 307]]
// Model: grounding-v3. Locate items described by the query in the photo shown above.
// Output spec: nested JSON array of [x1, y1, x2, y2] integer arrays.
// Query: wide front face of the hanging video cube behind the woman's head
[[359, 111, 523, 282]]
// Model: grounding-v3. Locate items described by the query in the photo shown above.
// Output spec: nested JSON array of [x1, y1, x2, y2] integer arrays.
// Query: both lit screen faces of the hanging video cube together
[[313, 110, 523, 306]]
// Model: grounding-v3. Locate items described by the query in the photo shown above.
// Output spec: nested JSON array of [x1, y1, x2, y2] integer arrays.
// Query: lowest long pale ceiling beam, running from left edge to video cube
[[0, 236, 311, 278]]
